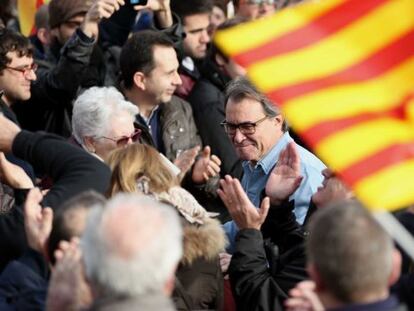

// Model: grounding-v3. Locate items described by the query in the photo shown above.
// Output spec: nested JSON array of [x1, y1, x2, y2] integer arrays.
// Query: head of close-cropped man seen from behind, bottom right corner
[[307, 201, 407, 311]]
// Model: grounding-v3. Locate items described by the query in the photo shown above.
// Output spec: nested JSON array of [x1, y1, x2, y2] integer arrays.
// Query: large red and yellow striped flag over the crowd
[[215, 0, 414, 210]]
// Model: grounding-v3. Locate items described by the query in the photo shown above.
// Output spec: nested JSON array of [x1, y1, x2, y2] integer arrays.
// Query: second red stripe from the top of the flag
[[269, 29, 414, 102]]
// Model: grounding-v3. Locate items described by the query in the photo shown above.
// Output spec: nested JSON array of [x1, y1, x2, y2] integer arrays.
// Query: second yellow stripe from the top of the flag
[[248, 1, 414, 92]]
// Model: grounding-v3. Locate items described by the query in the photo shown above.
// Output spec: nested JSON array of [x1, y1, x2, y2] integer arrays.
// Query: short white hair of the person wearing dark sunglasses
[[72, 86, 138, 144]]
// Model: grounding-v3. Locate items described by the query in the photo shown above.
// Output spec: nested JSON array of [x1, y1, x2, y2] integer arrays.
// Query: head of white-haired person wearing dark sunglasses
[[72, 87, 141, 160]]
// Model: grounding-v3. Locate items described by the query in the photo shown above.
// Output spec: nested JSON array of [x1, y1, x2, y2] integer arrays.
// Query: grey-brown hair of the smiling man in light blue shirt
[[224, 77, 288, 132]]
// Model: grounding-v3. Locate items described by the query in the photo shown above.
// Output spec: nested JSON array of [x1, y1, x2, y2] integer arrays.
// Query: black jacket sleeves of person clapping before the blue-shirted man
[[229, 202, 307, 311]]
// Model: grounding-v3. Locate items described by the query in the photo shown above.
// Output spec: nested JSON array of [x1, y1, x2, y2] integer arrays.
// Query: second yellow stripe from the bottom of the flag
[[315, 118, 414, 171]]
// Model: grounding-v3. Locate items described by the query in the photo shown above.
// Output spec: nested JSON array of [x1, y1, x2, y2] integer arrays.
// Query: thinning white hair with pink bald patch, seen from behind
[[81, 193, 182, 297]]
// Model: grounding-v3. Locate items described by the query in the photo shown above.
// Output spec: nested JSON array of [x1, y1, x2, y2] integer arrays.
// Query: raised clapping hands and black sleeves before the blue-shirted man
[[218, 143, 307, 311]]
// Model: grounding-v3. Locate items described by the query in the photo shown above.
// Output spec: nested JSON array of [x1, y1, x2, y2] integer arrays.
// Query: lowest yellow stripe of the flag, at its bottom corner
[[354, 160, 414, 211]]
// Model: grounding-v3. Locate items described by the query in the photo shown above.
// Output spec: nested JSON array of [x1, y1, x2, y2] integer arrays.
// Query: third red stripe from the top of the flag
[[299, 94, 414, 147]]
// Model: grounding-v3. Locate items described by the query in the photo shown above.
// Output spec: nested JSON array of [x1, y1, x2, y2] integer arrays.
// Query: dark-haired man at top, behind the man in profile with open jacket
[[171, 0, 213, 99]]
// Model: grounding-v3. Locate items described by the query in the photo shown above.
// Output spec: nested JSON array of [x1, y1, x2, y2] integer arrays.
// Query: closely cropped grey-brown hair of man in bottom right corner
[[307, 200, 394, 303]]
